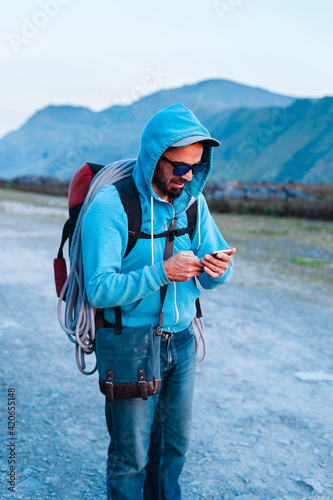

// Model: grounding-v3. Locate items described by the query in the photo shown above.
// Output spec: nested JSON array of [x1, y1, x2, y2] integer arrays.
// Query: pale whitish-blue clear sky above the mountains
[[0, 0, 333, 137]]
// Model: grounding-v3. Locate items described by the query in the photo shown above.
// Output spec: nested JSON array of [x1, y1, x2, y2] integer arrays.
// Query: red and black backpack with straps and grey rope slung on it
[[54, 160, 206, 375]]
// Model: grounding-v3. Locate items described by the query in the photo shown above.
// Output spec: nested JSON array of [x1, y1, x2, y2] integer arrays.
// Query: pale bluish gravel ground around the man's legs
[[0, 202, 333, 500]]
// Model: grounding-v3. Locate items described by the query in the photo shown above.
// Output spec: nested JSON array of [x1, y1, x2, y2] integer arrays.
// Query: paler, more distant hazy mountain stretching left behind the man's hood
[[0, 80, 295, 183]]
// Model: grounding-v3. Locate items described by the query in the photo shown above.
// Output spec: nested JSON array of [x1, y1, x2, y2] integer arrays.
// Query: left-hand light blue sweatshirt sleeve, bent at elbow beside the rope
[[81, 186, 169, 308]]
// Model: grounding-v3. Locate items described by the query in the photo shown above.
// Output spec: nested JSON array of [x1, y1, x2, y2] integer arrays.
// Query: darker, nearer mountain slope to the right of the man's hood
[[209, 97, 333, 184]]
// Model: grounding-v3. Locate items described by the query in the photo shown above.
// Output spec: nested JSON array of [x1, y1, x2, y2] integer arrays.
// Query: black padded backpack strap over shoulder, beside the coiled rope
[[114, 176, 142, 258]]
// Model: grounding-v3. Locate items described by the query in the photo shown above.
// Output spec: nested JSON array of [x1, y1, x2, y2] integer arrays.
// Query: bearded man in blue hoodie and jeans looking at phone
[[82, 104, 235, 500]]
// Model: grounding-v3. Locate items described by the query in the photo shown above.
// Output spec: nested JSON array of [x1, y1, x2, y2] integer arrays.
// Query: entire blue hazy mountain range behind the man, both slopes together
[[0, 79, 333, 182]]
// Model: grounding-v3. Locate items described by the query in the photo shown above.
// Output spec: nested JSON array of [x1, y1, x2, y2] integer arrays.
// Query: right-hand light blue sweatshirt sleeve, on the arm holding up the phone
[[192, 194, 234, 289]]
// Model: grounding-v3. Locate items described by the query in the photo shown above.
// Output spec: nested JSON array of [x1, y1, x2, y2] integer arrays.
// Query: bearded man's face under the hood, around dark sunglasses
[[152, 142, 203, 201]]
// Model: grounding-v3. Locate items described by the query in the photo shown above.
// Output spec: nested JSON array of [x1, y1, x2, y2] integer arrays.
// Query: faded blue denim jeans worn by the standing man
[[105, 325, 196, 500]]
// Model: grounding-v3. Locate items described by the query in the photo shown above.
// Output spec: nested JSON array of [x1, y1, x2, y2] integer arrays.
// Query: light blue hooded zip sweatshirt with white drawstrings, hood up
[[81, 103, 233, 332]]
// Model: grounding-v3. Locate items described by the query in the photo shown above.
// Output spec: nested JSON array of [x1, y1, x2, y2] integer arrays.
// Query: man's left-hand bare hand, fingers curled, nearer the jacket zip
[[163, 250, 204, 281]]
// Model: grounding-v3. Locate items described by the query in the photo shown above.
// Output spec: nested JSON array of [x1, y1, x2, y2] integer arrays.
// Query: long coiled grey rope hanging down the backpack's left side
[[58, 160, 136, 375]]
